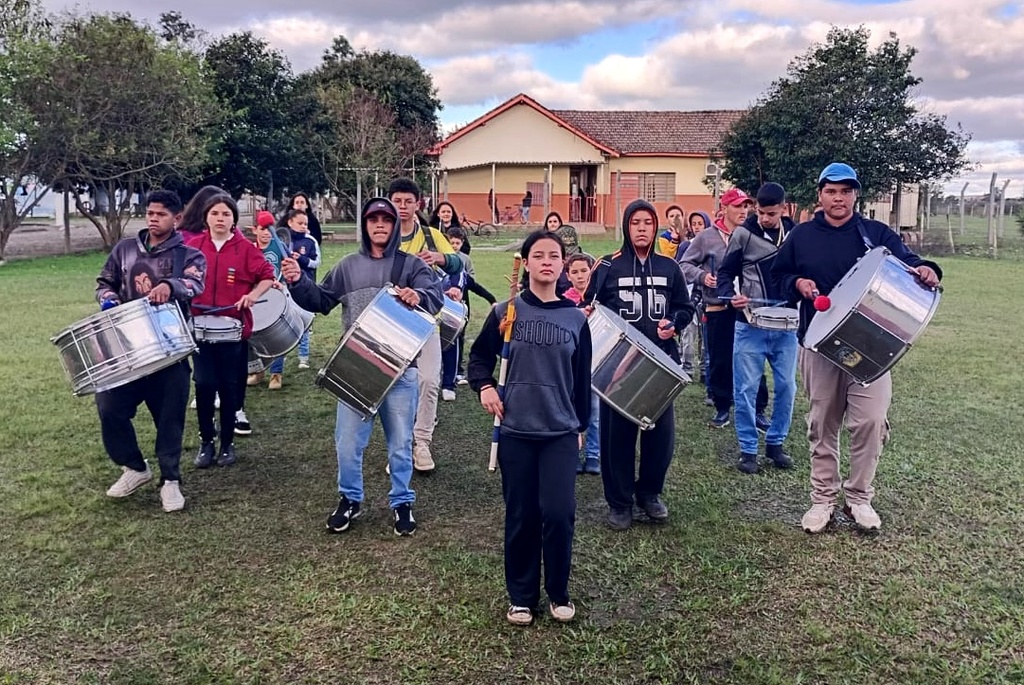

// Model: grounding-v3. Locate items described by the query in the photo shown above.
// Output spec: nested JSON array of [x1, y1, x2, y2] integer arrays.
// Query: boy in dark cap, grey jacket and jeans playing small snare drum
[[717, 183, 797, 473]]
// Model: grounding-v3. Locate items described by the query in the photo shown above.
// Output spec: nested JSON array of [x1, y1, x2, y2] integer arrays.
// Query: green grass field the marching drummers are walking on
[[0, 233, 1024, 685]]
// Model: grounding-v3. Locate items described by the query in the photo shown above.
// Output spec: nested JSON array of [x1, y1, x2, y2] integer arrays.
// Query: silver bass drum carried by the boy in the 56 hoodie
[[590, 304, 690, 430]]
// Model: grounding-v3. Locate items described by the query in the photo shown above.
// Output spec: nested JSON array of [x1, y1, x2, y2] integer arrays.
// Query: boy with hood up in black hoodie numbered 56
[[585, 200, 693, 530]]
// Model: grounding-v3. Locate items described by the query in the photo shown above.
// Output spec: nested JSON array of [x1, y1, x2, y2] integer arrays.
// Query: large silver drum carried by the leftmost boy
[[50, 298, 196, 395]]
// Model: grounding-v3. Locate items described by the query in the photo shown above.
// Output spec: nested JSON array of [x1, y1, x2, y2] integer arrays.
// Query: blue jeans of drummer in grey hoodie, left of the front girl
[[334, 368, 420, 509]]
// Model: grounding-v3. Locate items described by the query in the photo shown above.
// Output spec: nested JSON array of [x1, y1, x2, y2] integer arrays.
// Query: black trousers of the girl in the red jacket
[[193, 340, 243, 451]]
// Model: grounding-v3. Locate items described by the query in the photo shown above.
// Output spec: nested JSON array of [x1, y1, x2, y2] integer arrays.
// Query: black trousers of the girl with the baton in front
[[498, 433, 580, 608]]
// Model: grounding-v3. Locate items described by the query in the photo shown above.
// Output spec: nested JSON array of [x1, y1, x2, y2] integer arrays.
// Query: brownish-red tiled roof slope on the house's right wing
[[550, 110, 743, 155]]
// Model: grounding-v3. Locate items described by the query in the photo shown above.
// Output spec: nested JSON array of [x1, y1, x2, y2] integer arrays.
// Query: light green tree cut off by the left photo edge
[[0, 0, 50, 263]]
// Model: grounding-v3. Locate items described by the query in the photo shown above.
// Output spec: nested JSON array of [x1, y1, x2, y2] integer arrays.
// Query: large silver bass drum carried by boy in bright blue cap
[[803, 247, 942, 385]]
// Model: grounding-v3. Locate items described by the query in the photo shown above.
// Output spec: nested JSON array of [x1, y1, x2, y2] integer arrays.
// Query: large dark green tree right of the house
[[719, 27, 970, 213]]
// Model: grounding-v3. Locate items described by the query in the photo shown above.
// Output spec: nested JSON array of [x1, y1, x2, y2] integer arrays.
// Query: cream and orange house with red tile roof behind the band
[[430, 94, 742, 231]]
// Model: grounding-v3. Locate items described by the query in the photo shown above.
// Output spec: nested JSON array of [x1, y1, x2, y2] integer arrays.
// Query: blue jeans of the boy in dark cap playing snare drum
[[732, 322, 798, 455]]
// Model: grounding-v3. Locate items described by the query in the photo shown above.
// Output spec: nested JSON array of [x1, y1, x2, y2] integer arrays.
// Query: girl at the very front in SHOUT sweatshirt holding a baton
[[469, 230, 591, 626]]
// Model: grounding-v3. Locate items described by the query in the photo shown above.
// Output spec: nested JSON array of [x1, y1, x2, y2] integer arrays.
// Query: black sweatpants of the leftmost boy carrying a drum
[[96, 359, 188, 483]]
